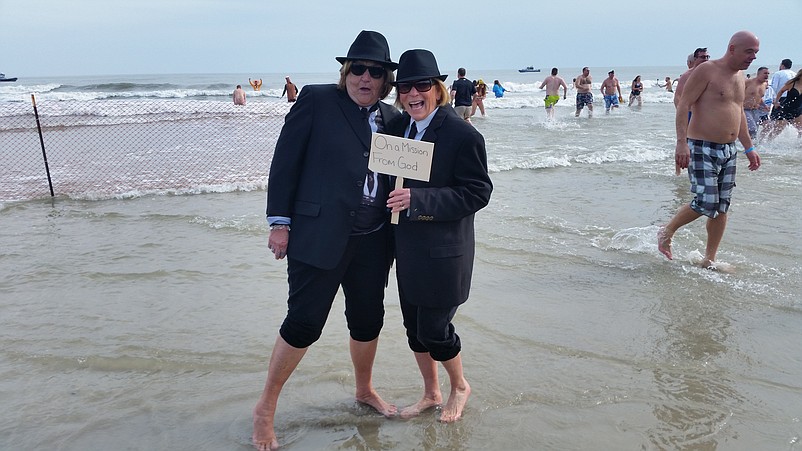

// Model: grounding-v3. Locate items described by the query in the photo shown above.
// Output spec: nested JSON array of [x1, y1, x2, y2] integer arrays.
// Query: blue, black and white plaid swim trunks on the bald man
[[688, 139, 737, 218]]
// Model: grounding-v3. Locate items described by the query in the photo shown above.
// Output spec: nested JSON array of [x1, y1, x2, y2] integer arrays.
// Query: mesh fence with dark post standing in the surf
[[0, 99, 289, 201]]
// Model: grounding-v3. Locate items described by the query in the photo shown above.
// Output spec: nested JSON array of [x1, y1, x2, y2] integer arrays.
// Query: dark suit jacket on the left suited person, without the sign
[[267, 85, 400, 269]]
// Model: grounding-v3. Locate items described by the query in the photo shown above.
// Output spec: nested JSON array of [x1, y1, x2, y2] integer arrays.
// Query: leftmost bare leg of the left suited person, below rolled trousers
[[252, 335, 308, 451]]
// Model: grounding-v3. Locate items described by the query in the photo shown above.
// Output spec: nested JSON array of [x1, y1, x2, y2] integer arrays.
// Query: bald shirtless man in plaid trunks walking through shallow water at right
[[657, 31, 760, 270]]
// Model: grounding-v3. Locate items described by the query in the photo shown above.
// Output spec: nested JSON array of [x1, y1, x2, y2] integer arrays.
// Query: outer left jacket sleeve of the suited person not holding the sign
[[267, 89, 315, 217]]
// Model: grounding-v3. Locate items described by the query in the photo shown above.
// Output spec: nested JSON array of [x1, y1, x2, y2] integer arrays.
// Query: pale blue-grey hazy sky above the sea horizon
[[0, 0, 802, 77]]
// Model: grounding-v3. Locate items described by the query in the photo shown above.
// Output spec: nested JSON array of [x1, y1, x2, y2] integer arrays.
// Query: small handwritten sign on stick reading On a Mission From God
[[368, 133, 434, 224]]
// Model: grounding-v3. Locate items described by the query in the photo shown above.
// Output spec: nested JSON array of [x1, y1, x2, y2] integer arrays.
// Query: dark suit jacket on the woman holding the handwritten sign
[[387, 106, 493, 307]]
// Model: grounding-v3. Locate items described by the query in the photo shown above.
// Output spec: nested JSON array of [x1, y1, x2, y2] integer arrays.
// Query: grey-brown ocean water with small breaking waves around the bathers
[[0, 67, 802, 450]]
